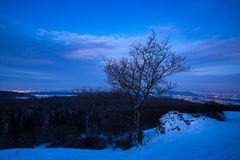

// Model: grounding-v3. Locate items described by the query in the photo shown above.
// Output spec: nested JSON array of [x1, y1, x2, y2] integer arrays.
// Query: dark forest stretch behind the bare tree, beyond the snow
[[0, 92, 240, 149]]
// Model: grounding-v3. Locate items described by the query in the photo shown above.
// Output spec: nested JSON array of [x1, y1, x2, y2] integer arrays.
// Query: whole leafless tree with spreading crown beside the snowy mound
[[104, 32, 189, 144]]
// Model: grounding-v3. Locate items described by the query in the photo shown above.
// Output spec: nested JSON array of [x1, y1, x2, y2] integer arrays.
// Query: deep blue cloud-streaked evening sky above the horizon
[[0, 0, 240, 93]]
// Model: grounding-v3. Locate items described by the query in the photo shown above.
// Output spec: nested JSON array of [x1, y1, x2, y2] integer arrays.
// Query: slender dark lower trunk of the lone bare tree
[[134, 108, 143, 145]]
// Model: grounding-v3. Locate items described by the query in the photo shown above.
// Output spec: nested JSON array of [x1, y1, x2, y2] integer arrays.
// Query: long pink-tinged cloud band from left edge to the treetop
[[0, 18, 138, 65]]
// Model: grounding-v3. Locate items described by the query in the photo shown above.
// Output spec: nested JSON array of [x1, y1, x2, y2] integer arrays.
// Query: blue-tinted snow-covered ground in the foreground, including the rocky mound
[[0, 112, 240, 160]]
